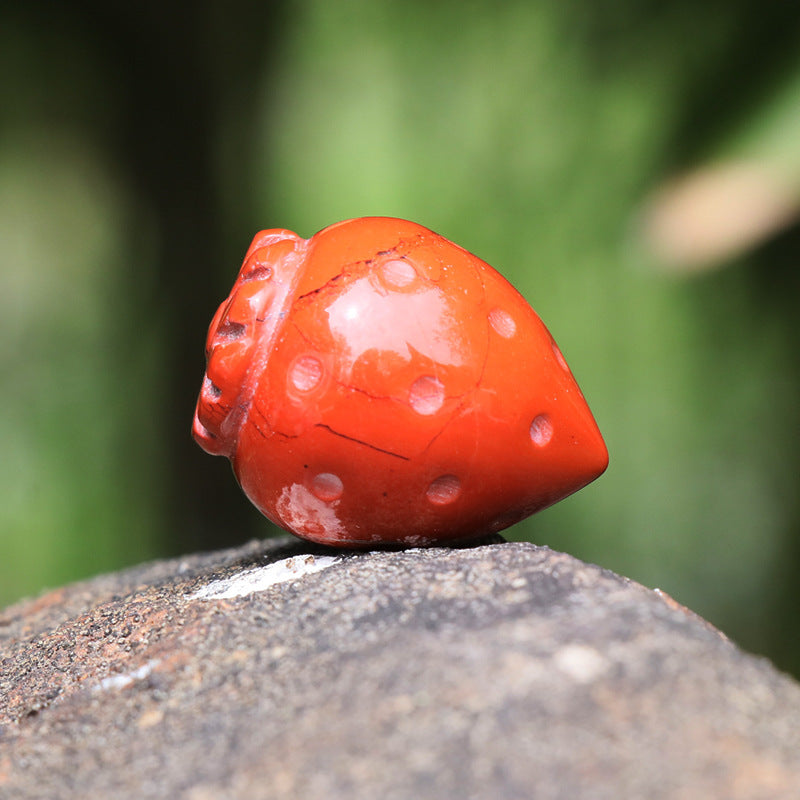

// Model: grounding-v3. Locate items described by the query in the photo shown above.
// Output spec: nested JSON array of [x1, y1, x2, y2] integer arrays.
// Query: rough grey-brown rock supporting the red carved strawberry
[[0, 539, 800, 800]]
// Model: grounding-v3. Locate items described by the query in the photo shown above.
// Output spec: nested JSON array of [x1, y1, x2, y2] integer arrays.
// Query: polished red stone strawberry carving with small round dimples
[[194, 217, 608, 547]]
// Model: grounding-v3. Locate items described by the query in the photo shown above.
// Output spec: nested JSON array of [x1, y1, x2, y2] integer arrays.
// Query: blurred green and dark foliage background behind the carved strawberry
[[0, 0, 800, 674]]
